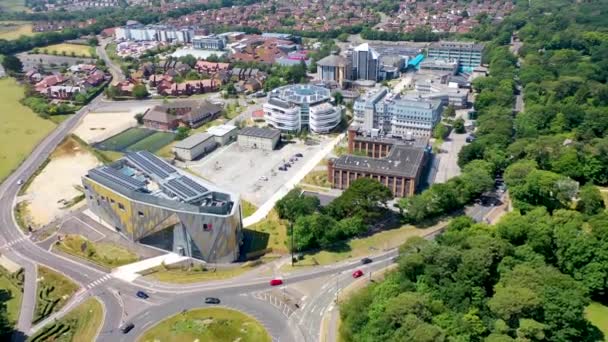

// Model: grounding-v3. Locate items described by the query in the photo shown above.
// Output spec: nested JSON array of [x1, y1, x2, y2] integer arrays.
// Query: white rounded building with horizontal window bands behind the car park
[[263, 84, 342, 133]]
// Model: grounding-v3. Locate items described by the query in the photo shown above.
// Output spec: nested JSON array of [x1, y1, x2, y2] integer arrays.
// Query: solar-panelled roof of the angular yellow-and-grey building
[[85, 151, 237, 215]]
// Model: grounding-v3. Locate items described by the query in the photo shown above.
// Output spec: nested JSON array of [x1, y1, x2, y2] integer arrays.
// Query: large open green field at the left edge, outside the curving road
[[0, 77, 55, 181]]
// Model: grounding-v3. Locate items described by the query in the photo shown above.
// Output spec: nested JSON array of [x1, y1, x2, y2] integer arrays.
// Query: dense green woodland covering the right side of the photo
[[340, 0, 608, 342]]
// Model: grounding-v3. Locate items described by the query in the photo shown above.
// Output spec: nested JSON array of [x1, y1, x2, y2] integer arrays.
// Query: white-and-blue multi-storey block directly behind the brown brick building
[[353, 88, 445, 139]]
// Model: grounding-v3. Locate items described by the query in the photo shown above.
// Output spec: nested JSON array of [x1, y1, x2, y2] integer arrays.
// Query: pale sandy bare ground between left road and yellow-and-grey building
[[25, 140, 101, 227]]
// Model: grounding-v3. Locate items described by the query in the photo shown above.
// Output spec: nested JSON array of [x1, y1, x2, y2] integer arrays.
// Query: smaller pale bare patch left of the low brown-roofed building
[[74, 112, 137, 144]]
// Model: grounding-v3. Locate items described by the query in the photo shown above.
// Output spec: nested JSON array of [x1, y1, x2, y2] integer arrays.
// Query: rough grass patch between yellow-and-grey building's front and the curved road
[[55, 235, 139, 268]]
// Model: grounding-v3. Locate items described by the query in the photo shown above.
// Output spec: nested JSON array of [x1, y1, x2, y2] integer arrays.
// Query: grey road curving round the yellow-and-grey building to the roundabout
[[0, 95, 418, 341]]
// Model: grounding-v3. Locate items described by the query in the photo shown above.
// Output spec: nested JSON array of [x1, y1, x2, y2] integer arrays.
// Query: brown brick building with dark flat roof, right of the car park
[[327, 127, 427, 197]]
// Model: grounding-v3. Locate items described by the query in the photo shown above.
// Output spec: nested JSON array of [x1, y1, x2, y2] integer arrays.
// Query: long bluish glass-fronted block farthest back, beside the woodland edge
[[428, 41, 483, 72]]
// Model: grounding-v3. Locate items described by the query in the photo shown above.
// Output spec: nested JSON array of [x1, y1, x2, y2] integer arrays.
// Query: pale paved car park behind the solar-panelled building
[[188, 137, 331, 206]]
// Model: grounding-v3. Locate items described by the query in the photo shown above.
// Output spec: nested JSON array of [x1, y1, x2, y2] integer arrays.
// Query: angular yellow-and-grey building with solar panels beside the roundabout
[[82, 151, 242, 263]]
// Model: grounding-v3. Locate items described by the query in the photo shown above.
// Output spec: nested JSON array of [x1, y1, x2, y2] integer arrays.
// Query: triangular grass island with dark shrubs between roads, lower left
[[32, 266, 78, 323]]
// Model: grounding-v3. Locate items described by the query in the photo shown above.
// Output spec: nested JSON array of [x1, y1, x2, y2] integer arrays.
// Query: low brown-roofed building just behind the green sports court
[[143, 101, 222, 131]]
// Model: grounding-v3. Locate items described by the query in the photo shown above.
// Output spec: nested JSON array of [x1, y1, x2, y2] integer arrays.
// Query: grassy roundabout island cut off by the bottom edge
[[138, 308, 270, 342]]
